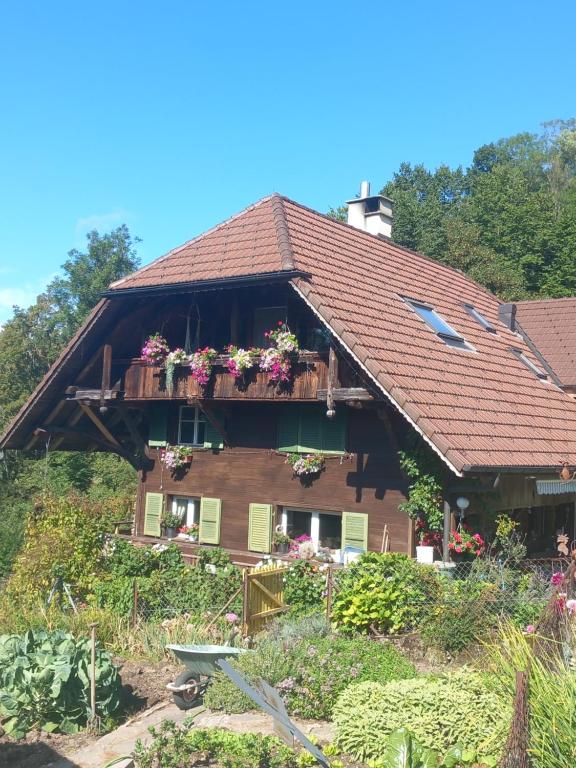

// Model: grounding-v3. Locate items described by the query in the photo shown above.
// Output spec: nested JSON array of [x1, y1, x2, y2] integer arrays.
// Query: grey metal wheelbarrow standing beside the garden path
[[166, 645, 245, 709]]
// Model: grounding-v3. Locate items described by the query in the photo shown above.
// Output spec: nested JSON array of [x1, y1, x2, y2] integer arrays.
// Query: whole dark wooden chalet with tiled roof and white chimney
[[0, 186, 576, 562]]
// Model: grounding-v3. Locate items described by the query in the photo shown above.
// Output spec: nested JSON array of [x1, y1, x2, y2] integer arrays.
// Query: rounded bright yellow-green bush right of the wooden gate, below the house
[[332, 552, 440, 634]]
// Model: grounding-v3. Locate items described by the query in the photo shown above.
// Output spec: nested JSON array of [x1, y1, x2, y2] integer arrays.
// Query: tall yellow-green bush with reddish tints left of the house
[[6, 494, 118, 602]]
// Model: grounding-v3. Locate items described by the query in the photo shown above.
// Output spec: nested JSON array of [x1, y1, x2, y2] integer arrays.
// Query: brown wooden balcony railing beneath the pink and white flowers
[[121, 352, 328, 400]]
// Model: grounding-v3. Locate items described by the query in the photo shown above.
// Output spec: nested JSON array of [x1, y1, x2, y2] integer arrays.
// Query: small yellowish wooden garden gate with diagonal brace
[[242, 563, 288, 636]]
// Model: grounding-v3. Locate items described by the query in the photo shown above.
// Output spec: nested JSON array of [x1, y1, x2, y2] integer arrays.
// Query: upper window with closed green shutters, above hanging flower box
[[277, 405, 348, 454]]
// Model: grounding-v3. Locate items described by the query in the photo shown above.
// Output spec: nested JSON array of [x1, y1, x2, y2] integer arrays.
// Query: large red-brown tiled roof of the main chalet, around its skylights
[[0, 195, 576, 473]]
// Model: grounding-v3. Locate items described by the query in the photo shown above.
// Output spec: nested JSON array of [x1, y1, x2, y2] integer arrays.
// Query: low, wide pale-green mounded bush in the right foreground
[[333, 671, 511, 760]]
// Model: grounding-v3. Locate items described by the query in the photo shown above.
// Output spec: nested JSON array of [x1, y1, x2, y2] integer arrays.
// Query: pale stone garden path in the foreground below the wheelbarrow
[[51, 702, 334, 768]]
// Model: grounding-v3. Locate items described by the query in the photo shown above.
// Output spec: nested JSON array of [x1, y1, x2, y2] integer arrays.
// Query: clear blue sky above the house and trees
[[0, 0, 576, 322]]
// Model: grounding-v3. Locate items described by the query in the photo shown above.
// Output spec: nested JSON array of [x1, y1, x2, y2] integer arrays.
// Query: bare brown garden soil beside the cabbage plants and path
[[0, 659, 182, 768]]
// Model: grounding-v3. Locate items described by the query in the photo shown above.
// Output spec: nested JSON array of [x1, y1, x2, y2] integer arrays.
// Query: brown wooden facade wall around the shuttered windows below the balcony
[[136, 403, 412, 552]]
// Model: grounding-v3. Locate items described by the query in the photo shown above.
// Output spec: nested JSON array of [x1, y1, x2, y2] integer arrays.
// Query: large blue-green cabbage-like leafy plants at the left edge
[[0, 630, 121, 739]]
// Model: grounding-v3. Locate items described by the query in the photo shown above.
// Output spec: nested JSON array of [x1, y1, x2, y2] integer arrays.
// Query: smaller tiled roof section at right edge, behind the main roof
[[516, 296, 576, 387]]
